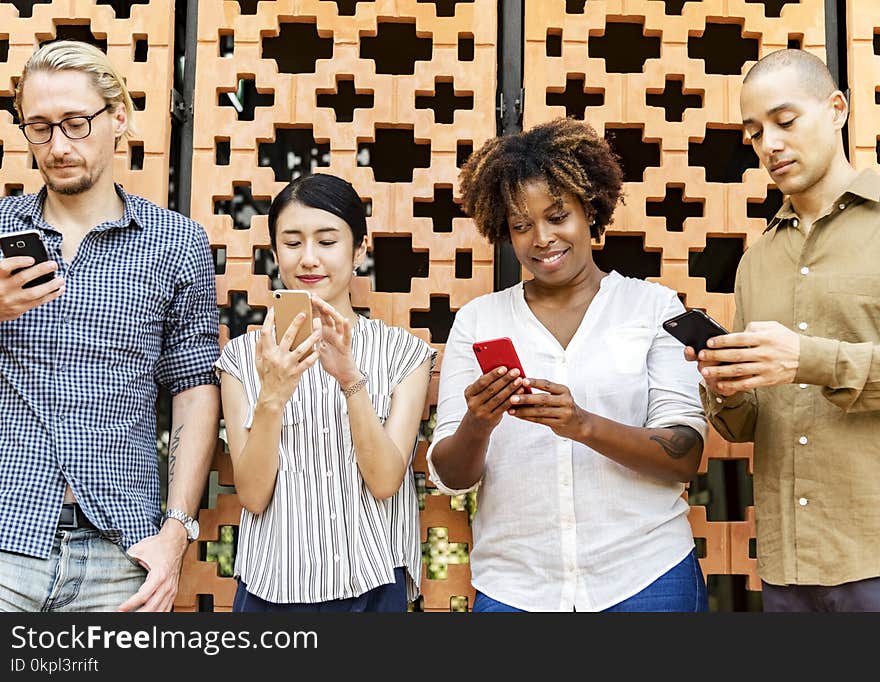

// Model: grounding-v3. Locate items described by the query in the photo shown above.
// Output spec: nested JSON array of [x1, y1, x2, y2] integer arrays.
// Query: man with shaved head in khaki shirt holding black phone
[[685, 50, 880, 611]]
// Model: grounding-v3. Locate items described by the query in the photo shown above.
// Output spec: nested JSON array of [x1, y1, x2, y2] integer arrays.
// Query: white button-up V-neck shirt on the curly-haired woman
[[428, 272, 706, 611]]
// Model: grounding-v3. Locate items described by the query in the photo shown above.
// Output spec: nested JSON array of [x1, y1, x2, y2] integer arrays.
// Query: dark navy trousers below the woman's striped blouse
[[232, 568, 407, 613]]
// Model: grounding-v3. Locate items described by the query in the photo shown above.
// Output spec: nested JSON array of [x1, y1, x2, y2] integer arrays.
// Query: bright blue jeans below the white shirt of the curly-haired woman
[[474, 550, 709, 613]]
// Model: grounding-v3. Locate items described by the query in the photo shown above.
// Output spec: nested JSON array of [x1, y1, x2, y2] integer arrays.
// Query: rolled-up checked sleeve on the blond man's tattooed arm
[[155, 226, 220, 395]]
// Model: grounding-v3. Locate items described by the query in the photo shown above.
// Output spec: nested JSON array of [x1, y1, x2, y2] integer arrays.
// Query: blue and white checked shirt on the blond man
[[0, 185, 219, 558]]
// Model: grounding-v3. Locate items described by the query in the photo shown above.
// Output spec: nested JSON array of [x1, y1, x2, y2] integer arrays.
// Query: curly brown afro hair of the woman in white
[[459, 117, 623, 244]]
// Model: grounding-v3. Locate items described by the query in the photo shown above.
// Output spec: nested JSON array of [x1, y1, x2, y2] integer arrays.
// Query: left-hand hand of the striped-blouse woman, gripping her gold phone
[[255, 308, 321, 407]]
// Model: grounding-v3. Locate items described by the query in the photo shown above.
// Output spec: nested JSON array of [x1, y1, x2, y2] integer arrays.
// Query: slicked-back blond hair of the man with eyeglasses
[[14, 40, 135, 137]]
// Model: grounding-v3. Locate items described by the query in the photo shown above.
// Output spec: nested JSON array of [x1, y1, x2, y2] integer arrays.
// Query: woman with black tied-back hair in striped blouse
[[216, 174, 435, 611]]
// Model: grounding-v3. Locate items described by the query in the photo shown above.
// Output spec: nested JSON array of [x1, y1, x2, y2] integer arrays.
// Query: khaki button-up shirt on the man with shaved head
[[700, 171, 880, 585]]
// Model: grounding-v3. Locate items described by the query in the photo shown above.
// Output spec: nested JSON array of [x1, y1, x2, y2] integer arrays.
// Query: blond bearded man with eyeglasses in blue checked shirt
[[0, 41, 219, 611]]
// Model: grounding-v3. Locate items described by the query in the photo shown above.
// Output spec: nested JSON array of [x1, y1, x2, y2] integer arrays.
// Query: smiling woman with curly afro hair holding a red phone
[[428, 118, 708, 611]]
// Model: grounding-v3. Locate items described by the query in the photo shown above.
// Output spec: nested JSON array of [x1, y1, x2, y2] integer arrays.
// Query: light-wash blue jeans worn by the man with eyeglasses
[[0, 528, 147, 612]]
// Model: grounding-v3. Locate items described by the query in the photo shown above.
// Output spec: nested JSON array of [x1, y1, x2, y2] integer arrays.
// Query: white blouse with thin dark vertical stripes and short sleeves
[[215, 318, 436, 603]]
